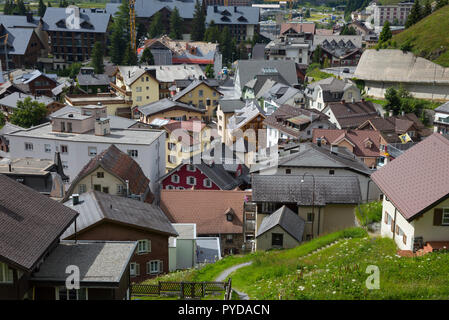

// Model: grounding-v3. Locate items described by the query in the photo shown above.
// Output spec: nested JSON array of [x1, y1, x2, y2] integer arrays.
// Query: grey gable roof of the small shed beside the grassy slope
[[256, 206, 305, 242]]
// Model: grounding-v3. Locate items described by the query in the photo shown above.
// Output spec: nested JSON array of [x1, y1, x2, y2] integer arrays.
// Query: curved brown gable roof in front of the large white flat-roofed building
[[64, 145, 150, 200]]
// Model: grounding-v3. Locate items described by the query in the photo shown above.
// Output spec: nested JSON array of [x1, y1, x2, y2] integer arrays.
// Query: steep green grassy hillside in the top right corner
[[392, 5, 449, 67]]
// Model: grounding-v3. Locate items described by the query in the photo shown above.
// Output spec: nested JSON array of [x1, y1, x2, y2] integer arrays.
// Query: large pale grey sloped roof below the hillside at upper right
[[354, 49, 449, 84]]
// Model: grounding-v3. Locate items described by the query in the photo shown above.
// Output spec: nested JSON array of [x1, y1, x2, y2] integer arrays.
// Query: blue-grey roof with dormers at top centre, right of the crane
[[206, 6, 260, 25]]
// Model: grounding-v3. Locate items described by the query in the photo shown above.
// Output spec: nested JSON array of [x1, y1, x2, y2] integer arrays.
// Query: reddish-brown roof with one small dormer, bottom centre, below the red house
[[161, 190, 251, 234]]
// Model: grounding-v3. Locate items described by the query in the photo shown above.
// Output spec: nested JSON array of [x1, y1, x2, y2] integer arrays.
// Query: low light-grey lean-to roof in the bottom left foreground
[[32, 241, 137, 287]]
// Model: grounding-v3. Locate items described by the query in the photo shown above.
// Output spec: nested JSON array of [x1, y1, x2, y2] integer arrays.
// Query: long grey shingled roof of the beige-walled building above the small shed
[[252, 174, 361, 206]]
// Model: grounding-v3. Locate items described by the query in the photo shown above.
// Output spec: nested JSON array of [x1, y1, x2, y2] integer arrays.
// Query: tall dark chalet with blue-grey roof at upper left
[[42, 6, 111, 70]]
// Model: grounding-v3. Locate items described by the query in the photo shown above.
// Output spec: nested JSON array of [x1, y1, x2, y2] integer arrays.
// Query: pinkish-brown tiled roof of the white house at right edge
[[371, 133, 449, 220]]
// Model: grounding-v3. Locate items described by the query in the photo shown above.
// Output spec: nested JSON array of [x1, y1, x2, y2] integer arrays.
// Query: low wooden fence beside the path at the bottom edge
[[131, 279, 232, 300]]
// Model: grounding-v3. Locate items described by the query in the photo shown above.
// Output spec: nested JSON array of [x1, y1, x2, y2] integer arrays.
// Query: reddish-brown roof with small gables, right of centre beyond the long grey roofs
[[312, 129, 380, 157]]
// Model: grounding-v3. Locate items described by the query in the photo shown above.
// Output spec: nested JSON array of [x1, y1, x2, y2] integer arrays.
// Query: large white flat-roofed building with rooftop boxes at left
[[5, 108, 165, 191]]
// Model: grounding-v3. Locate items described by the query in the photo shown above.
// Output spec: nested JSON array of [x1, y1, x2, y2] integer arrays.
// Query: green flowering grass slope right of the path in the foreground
[[229, 233, 449, 299]]
